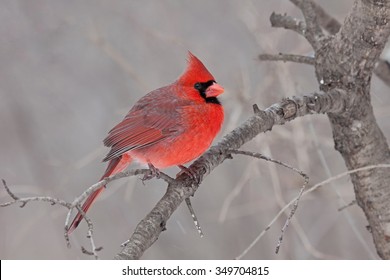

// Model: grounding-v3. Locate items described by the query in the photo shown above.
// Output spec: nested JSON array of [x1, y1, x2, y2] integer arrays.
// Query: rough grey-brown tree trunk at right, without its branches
[[308, 0, 390, 259]]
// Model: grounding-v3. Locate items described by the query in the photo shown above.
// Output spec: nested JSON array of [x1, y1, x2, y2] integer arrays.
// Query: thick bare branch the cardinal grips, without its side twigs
[[115, 90, 348, 259]]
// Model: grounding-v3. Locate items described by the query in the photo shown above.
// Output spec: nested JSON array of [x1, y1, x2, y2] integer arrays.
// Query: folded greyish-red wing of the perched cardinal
[[103, 111, 178, 161]]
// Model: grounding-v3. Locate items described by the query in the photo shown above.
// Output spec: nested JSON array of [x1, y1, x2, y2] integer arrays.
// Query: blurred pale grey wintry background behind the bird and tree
[[0, 0, 390, 259]]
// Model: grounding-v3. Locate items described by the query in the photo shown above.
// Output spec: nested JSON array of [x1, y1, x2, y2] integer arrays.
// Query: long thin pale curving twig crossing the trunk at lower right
[[236, 164, 390, 260]]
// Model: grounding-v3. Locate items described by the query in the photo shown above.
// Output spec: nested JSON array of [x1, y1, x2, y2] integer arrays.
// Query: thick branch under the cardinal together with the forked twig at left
[[0, 89, 348, 259]]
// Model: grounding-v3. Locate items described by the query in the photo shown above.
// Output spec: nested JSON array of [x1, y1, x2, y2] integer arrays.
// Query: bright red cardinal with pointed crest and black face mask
[[68, 52, 224, 234]]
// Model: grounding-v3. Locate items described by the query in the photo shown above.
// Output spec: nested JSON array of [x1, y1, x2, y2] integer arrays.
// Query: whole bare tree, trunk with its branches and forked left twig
[[5, 0, 390, 259]]
